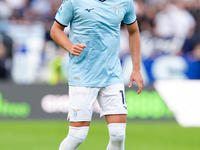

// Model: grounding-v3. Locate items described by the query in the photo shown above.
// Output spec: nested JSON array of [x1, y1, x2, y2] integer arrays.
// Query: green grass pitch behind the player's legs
[[0, 120, 200, 150]]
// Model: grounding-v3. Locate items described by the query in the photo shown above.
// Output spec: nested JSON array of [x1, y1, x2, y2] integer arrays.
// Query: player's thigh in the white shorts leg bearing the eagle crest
[[68, 86, 99, 123]]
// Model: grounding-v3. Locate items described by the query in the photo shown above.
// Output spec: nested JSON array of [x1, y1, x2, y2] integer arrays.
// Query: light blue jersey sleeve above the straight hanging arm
[[123, 0, 136, 24]]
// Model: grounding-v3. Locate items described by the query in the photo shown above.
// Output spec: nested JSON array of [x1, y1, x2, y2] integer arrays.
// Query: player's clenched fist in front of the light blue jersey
[[69, 43, 86, 56]]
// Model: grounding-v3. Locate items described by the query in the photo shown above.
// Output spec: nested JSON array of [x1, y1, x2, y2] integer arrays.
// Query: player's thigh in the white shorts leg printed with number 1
[[97, 83, 128, 121]]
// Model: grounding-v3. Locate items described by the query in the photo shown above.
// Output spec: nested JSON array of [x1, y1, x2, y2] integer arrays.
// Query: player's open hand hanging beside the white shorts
[[129, 70, 144, 94]]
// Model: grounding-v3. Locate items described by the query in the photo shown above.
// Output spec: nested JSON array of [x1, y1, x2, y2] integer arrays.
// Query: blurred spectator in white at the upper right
[[155, 0, 195, 39]]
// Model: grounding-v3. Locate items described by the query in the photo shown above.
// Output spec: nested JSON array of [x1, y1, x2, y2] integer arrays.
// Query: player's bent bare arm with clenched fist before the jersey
[[51, 21, 86, 56]]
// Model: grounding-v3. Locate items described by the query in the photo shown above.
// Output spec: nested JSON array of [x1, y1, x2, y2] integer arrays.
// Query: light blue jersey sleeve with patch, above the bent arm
[[55, 0, 73, 26]]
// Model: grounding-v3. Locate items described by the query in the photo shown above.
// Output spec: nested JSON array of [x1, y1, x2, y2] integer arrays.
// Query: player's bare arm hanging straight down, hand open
[[127, 21, 144, 94]]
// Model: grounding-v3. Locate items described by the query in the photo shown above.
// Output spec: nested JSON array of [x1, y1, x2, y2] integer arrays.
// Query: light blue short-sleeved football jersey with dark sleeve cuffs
[[55, 0, 136, 87]]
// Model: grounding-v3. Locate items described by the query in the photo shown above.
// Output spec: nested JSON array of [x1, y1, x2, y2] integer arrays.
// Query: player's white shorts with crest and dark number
[[68, 83, 128, 122]]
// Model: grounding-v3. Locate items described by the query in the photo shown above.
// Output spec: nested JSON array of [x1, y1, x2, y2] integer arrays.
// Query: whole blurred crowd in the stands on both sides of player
[[0, 0, 200, 84]]
